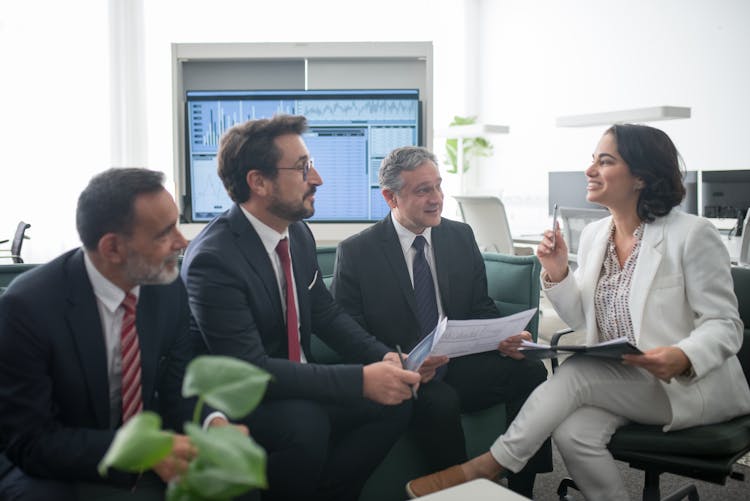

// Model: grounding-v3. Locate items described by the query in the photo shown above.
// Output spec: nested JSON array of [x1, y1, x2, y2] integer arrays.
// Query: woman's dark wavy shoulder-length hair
[[605, 124, 685, 222]]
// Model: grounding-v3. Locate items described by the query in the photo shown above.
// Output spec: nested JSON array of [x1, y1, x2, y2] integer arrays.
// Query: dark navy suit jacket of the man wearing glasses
[[182, 205, 389, 401]]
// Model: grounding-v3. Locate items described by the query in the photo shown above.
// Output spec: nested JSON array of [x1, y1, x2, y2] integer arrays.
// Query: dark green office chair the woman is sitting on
[[550, 267, 750, 501]]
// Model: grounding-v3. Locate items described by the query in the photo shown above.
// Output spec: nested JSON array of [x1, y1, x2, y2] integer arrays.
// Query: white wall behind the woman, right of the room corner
[[476, 0, 750, 232]]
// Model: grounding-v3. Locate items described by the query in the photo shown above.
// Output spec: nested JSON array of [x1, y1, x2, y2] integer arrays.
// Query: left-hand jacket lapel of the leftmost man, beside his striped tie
[[65, 250, 109, 428]]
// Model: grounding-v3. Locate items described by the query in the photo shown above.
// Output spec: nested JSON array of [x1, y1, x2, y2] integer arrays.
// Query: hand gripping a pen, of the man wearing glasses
[[362, 361, 420, 405]]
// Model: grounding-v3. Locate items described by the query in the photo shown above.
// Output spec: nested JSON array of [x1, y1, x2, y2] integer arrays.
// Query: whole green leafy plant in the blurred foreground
[[99, 356, 271, 501]]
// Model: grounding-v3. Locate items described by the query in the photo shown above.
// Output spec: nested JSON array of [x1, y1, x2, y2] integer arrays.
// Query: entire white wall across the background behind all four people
[[0, 0, 750, 262]]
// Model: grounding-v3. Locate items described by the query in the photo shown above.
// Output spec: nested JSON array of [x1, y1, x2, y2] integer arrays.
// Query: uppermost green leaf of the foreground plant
[[182, 355, 271, 419]]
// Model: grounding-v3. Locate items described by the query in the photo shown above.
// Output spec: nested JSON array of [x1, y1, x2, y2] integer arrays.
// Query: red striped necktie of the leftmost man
[[120, 292, 143, 424]]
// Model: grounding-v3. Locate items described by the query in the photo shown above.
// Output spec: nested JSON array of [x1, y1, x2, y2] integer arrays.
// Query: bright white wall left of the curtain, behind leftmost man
[[0, 0, 109, 264]]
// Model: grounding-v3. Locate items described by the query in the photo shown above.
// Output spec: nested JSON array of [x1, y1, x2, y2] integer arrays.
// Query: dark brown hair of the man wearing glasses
[[217, 115, 307, 203]]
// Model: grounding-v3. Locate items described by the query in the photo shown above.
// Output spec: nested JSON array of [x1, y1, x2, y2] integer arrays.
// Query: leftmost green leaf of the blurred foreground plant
[[98, 411, 173, 476]]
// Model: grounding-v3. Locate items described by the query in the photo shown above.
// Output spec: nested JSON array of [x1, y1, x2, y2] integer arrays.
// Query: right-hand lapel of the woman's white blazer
[[630, 217, 666, 341]]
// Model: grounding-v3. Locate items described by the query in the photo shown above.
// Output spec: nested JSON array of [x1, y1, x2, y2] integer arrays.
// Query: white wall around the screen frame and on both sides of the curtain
[[0, 0, 477, 264]]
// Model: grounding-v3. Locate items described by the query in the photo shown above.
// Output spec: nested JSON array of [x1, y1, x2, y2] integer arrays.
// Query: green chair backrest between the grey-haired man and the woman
[[482, 252, 542, 340]]
